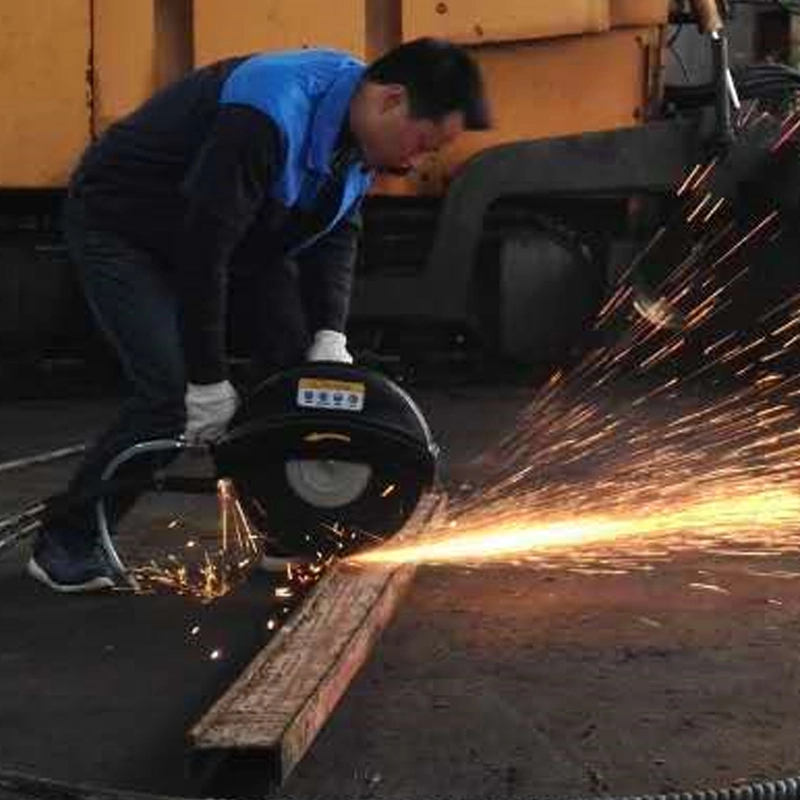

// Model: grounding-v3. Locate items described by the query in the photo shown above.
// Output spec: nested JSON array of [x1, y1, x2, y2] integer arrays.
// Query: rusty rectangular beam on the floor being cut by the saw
[[189, 497, 443, 783]]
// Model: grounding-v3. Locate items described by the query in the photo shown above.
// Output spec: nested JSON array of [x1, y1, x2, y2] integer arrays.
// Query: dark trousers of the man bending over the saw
[[47, 199, 307, 544]]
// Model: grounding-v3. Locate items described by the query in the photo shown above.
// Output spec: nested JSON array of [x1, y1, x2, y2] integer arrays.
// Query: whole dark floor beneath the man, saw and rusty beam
[[0, 387, 800, 800]]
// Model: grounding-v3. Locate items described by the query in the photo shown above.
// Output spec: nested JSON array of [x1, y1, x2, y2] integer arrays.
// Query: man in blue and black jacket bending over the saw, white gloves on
[[28, 39, 488, 592]]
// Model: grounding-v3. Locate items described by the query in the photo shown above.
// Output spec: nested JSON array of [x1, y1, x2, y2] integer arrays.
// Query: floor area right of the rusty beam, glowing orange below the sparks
[[276, 560, 800, 800]]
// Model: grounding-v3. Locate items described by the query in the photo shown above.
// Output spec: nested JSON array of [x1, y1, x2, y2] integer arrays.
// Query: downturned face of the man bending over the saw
[[351, 84, 464, 172]]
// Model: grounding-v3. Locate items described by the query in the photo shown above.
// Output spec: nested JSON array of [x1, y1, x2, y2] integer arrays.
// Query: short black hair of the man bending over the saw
[[365, 37, 491, 131]]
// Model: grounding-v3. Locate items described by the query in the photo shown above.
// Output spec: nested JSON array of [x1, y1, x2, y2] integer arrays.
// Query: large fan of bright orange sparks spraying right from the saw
[[350, 119, 800, 576]]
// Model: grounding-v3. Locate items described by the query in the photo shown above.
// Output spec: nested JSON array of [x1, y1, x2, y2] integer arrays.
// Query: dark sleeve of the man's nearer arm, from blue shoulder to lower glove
[[176, 105, 284, 383]]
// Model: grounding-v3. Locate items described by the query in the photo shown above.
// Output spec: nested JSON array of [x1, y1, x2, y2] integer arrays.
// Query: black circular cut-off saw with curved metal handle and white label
[[0, 363, 439, 575]]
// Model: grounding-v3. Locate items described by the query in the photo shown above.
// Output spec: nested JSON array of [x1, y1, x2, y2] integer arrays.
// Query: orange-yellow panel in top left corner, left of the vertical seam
[[0, 0, 90, 188]]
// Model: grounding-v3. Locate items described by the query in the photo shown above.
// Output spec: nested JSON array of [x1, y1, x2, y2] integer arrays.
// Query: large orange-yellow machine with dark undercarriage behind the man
[[0, 0, 797, 388]]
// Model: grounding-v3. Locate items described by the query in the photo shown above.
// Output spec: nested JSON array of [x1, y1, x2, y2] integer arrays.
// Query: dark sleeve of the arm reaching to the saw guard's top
[[297, 210, 362, 334]]
